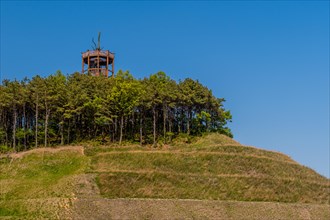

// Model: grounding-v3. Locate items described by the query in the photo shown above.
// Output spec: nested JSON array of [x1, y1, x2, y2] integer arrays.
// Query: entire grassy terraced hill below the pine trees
[[0, 134, 330, 219]]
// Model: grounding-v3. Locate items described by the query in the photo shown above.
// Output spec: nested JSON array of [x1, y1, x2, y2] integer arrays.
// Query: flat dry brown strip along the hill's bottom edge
[[73, 199, 330, 220]]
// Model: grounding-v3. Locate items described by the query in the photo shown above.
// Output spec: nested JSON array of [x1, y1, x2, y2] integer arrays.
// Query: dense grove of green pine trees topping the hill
[[0, 70, 232, 151]]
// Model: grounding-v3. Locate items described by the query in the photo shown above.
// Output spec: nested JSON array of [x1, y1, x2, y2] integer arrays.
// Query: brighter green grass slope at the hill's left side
[[0, 148, 88, 219]]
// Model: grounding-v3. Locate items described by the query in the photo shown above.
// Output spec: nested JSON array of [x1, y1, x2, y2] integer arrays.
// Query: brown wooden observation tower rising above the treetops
[[81, 33, 115, 77]]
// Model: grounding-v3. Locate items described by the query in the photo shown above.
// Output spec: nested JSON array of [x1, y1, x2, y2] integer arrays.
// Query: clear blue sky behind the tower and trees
[[0, 1, 330, 177]]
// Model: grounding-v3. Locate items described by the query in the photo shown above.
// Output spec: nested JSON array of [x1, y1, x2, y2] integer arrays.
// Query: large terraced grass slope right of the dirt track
[[87, 134, 330, 204]]
